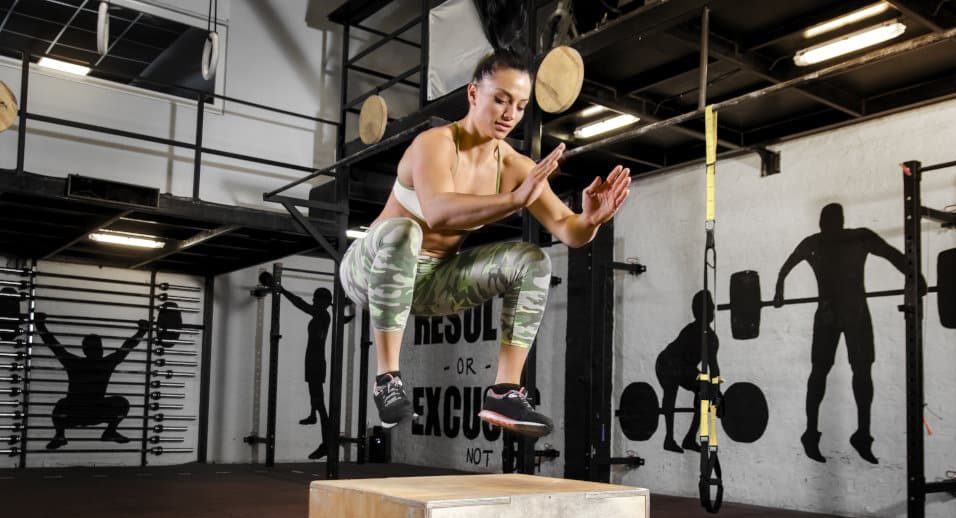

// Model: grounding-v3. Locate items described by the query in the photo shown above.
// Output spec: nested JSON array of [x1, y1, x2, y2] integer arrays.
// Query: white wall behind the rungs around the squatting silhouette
[[0, 256, 202, 468]]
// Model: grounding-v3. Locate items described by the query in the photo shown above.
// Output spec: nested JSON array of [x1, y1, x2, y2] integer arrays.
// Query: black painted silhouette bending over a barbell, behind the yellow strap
[[654, 290, 720, 453]]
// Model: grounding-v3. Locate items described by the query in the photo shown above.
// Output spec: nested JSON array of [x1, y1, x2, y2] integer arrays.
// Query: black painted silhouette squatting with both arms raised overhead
[[36, 313, 149, 450]]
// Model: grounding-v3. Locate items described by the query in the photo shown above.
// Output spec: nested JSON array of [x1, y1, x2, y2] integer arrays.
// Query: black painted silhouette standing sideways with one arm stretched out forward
[[260, 275, 354, 459]]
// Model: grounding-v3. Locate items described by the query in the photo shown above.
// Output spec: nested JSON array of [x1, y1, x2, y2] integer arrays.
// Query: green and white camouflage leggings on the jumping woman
[[341, 218, 551, 347]]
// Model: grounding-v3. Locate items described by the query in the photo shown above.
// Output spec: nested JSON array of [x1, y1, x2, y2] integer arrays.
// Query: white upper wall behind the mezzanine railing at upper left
[[0, 0, 417, 212]]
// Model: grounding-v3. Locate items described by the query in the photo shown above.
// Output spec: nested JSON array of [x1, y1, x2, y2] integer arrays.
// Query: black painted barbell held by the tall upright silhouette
[[717, 248, 956, 340]]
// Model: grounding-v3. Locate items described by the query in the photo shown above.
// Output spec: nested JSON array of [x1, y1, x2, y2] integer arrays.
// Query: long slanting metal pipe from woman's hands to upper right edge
[[564, 24, 956, 161]]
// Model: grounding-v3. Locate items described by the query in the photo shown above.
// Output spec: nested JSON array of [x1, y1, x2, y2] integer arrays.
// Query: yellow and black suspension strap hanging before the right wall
[[697, 105, 724, 513]]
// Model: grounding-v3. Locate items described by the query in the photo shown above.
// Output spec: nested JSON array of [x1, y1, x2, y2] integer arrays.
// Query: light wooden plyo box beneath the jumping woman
[[309, 474, 650, 518]]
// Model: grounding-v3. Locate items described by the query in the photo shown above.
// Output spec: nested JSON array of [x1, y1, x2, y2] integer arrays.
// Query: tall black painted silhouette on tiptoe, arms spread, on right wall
[[774, 203, 926, 464]]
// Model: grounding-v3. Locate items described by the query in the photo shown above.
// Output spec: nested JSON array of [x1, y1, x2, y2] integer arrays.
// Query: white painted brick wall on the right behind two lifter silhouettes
[[614, 98, 956, 517]]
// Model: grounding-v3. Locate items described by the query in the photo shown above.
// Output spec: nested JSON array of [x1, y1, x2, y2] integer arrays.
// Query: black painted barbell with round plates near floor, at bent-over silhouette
[[615, 381, 770, 443]]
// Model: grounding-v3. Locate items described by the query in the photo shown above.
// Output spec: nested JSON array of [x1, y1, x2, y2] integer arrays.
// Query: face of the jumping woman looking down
[[468, 68, 531, 139]]
